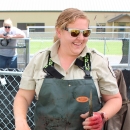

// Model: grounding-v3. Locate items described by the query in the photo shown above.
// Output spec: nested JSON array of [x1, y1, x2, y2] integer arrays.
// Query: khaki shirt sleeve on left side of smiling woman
[[19, 50, 48, 91]]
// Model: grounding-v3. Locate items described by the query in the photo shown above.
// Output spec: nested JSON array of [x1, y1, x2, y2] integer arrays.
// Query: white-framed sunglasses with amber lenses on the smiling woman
[[64, 28, 91, 37]]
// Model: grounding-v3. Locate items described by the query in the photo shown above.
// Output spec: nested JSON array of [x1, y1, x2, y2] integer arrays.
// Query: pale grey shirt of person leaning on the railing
[[0, 27, 25, 57]]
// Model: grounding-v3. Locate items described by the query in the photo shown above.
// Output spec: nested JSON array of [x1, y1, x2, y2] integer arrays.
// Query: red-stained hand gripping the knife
[[81, 112, 104, 130]]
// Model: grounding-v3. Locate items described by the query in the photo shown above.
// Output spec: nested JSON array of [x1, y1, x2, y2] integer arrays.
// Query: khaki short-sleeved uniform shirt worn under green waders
[[20, 41, 119, 97]]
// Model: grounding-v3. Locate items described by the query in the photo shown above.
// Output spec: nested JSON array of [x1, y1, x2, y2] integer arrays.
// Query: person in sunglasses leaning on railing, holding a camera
[[0, 19, 25, 68]]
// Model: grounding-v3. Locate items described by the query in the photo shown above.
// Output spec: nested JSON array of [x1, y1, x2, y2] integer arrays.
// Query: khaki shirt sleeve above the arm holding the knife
[[97, 58, 119, 95]]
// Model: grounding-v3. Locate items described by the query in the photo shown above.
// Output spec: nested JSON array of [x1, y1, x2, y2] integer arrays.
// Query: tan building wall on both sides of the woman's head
[[0, 12, 130, 30]]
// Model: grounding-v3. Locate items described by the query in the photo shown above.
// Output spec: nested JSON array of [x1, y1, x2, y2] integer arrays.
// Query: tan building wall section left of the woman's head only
[[0, 12, 59, 26]]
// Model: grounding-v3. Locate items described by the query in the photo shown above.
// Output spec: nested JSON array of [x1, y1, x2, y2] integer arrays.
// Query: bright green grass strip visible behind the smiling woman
[[30, 40, 122, 55]]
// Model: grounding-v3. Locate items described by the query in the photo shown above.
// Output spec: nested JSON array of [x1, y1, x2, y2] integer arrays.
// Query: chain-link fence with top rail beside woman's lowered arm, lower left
[[0, 69, 36, 130]]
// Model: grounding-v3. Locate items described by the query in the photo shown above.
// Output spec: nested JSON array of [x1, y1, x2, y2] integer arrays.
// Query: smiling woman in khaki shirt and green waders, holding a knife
[[14, 8, 122, 130]]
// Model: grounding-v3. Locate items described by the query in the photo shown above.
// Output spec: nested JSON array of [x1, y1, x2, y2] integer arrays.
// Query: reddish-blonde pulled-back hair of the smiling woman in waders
[[53, 8, 90, 42]]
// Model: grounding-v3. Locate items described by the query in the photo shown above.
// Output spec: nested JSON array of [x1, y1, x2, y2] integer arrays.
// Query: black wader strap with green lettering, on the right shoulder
[[75, 53, 92, 79]]
